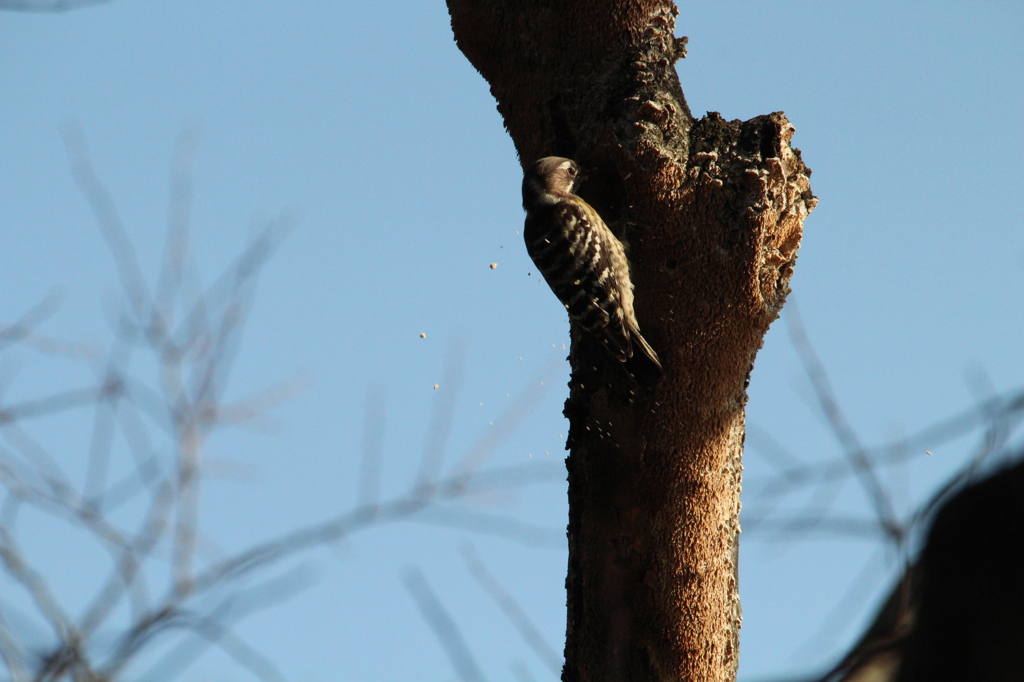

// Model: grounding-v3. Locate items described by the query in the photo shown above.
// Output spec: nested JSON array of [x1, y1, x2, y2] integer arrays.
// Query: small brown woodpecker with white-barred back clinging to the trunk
[[522, 157, 662, 370]]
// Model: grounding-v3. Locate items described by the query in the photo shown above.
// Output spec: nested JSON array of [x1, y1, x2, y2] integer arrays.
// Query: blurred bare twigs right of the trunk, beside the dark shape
[[743, 301, 1024, 682]]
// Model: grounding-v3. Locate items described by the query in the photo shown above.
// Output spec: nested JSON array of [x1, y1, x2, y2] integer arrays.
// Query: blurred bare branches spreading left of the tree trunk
[[0, 129, 563, 682]]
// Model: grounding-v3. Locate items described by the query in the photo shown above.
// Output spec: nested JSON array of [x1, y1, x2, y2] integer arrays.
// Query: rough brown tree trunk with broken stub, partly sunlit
[[447, 0, 815, 682]]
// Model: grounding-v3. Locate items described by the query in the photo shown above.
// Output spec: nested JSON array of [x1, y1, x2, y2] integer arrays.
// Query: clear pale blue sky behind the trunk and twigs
[[0, 0, 1024, 680]]
